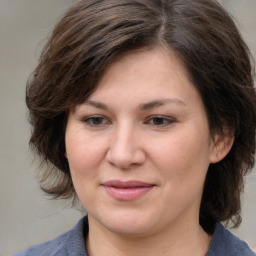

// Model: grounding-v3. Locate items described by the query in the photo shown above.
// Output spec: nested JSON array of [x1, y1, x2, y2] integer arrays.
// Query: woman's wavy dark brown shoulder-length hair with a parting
[[26, 0, 256, 233]]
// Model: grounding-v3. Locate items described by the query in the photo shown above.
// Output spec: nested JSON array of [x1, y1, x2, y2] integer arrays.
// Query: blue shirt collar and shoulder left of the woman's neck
[[13, 218, 87, 256]]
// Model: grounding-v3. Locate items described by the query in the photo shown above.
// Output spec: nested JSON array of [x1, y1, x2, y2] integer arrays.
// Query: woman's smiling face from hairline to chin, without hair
[[66, 47, 216, 236]]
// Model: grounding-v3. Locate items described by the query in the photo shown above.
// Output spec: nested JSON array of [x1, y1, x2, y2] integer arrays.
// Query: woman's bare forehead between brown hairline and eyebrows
[[85, 47, 195, 105]]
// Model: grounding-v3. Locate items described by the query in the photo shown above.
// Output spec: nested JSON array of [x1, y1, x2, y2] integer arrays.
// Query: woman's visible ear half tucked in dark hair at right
[[210, 129, 234, 163]]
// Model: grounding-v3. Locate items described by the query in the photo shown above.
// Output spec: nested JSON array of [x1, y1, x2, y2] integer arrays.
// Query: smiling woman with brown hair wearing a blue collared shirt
[[14, 0, 256, 256]]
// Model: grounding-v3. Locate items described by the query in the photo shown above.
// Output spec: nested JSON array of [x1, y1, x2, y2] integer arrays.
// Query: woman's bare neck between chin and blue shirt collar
[[86, 217, 211, 256]]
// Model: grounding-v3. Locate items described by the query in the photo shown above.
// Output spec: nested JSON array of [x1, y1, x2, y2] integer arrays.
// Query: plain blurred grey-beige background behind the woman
[[0, 0, 256, 256]]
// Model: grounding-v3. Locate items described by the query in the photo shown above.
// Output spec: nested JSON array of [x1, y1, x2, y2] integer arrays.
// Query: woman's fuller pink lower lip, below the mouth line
[[104, 186, 154, 201]]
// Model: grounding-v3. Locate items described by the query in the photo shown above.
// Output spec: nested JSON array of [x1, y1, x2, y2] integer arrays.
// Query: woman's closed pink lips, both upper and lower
[[102, 180, 155, 201]]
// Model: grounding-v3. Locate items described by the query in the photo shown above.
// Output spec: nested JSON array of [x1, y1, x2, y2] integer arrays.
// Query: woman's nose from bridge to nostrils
[[106, 125, 146, 169]]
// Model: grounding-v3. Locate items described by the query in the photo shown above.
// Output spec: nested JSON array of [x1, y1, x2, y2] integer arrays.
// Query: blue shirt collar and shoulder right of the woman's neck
[[207, 223, 256, 256]]
